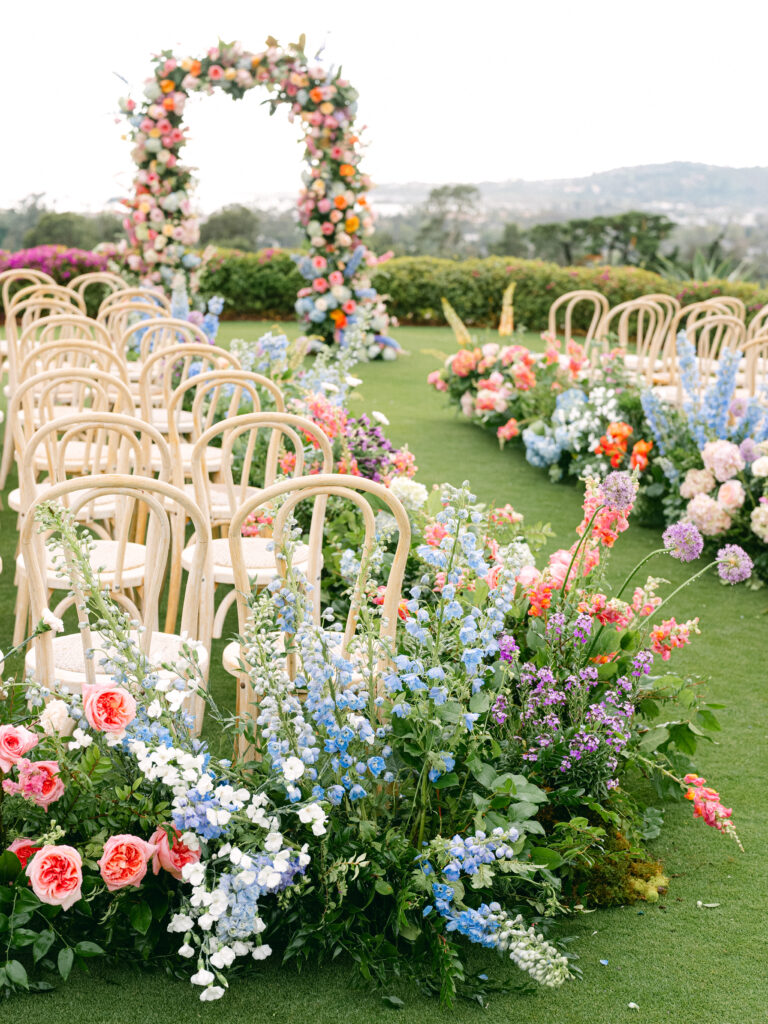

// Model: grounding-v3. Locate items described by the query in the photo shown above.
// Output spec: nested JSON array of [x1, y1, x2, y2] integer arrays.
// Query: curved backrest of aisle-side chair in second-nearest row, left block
[[189, 412, 334, 526]]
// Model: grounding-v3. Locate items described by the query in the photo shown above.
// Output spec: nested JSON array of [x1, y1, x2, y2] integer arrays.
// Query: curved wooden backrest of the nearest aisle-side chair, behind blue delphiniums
[[229, 473, 411, 651]]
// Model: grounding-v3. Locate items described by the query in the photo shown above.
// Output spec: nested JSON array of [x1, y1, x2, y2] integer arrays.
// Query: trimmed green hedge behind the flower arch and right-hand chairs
[[196, 249, 768, 330]]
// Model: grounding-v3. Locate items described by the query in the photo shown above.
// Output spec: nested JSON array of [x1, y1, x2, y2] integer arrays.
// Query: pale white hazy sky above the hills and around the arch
[[0, 0, 768, 211]]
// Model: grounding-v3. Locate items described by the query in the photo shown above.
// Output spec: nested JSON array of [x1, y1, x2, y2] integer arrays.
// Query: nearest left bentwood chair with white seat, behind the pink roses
[[22, 473, 213, 731]]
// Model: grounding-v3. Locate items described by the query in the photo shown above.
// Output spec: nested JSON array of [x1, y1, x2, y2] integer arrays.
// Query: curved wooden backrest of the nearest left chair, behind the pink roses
[[20, 473, 213, 684]]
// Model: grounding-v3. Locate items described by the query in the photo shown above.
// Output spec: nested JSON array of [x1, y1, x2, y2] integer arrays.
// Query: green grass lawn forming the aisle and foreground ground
[[7, 323, 768, 1024]]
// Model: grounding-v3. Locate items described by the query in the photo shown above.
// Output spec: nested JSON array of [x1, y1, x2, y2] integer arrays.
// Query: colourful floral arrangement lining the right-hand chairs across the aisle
[[428, 332, 768, 581]]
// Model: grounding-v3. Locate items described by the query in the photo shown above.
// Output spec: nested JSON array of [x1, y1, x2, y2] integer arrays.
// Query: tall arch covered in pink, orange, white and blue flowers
[[120, 37, 393, 344]]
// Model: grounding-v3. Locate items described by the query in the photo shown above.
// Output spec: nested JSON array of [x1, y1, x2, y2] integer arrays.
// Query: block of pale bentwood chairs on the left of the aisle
[[0, 268, 410, 745]]
